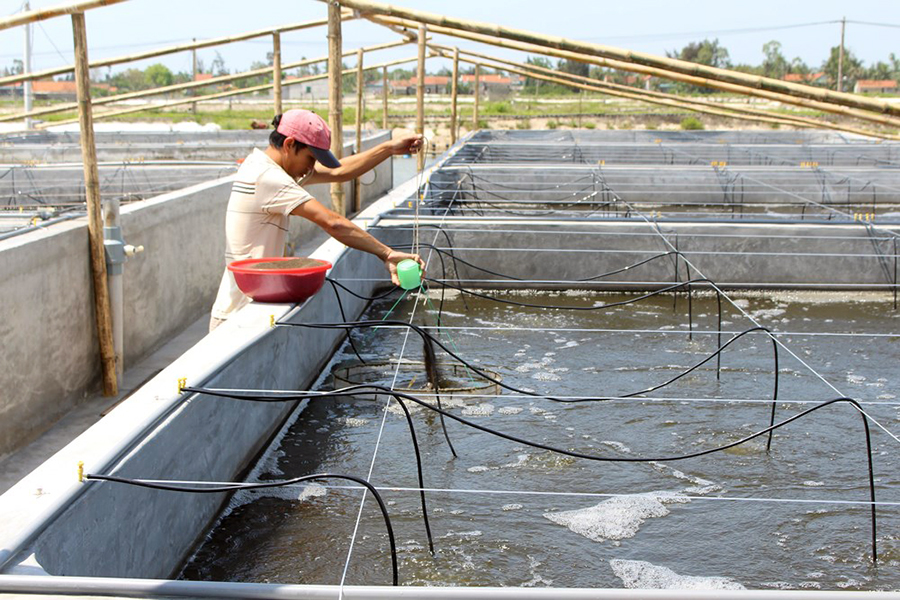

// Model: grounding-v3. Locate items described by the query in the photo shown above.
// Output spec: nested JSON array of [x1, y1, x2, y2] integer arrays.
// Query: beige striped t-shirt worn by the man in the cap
[[212, 149, 312, 319]]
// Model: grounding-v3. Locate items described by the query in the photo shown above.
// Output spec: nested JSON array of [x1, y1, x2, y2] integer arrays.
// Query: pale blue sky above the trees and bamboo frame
[[0, 0, 900, 77]]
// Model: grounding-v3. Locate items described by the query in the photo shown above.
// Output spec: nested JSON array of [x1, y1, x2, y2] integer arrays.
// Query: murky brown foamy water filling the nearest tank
[[181, 290, 900, 590]]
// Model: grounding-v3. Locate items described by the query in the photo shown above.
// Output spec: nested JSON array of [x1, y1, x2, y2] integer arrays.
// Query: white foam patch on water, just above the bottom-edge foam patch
[[544, 491, 690, 542]]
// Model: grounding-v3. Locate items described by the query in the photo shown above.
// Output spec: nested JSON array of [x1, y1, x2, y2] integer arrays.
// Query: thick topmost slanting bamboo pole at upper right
[[336, 0, 900, 115]]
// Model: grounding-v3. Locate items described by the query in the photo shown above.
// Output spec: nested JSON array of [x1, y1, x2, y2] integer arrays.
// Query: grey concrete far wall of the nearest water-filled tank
[[372, 217, 900, 289]]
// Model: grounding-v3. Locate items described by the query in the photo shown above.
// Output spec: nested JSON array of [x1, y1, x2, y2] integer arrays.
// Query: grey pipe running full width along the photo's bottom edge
[[0, 575, 900, 600]]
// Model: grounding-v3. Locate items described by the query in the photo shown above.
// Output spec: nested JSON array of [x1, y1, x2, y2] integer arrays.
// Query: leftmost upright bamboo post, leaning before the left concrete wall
[[72, 13, 119, 396]]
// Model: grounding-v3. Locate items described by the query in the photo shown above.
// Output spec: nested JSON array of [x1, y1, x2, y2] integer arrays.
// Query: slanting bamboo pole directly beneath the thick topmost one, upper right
[[370, 17, 900, 127]]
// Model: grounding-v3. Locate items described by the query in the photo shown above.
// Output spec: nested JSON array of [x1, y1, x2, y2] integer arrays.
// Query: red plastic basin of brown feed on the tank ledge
[[228, 256, 331, 303]]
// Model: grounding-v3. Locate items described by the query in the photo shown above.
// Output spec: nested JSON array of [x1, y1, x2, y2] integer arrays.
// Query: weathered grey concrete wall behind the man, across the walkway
[[0, 133, 392, 455]]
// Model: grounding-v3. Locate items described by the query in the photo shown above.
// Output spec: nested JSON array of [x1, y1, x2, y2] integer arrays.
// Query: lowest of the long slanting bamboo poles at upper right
[[430, 44, 900, 139]]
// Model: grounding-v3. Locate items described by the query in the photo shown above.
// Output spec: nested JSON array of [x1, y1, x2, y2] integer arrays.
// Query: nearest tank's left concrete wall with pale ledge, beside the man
[[0, 186, 411, 577]]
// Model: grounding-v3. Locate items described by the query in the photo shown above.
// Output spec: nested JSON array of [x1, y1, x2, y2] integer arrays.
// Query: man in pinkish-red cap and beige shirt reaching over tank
[[209, 109, 425, 331]]
